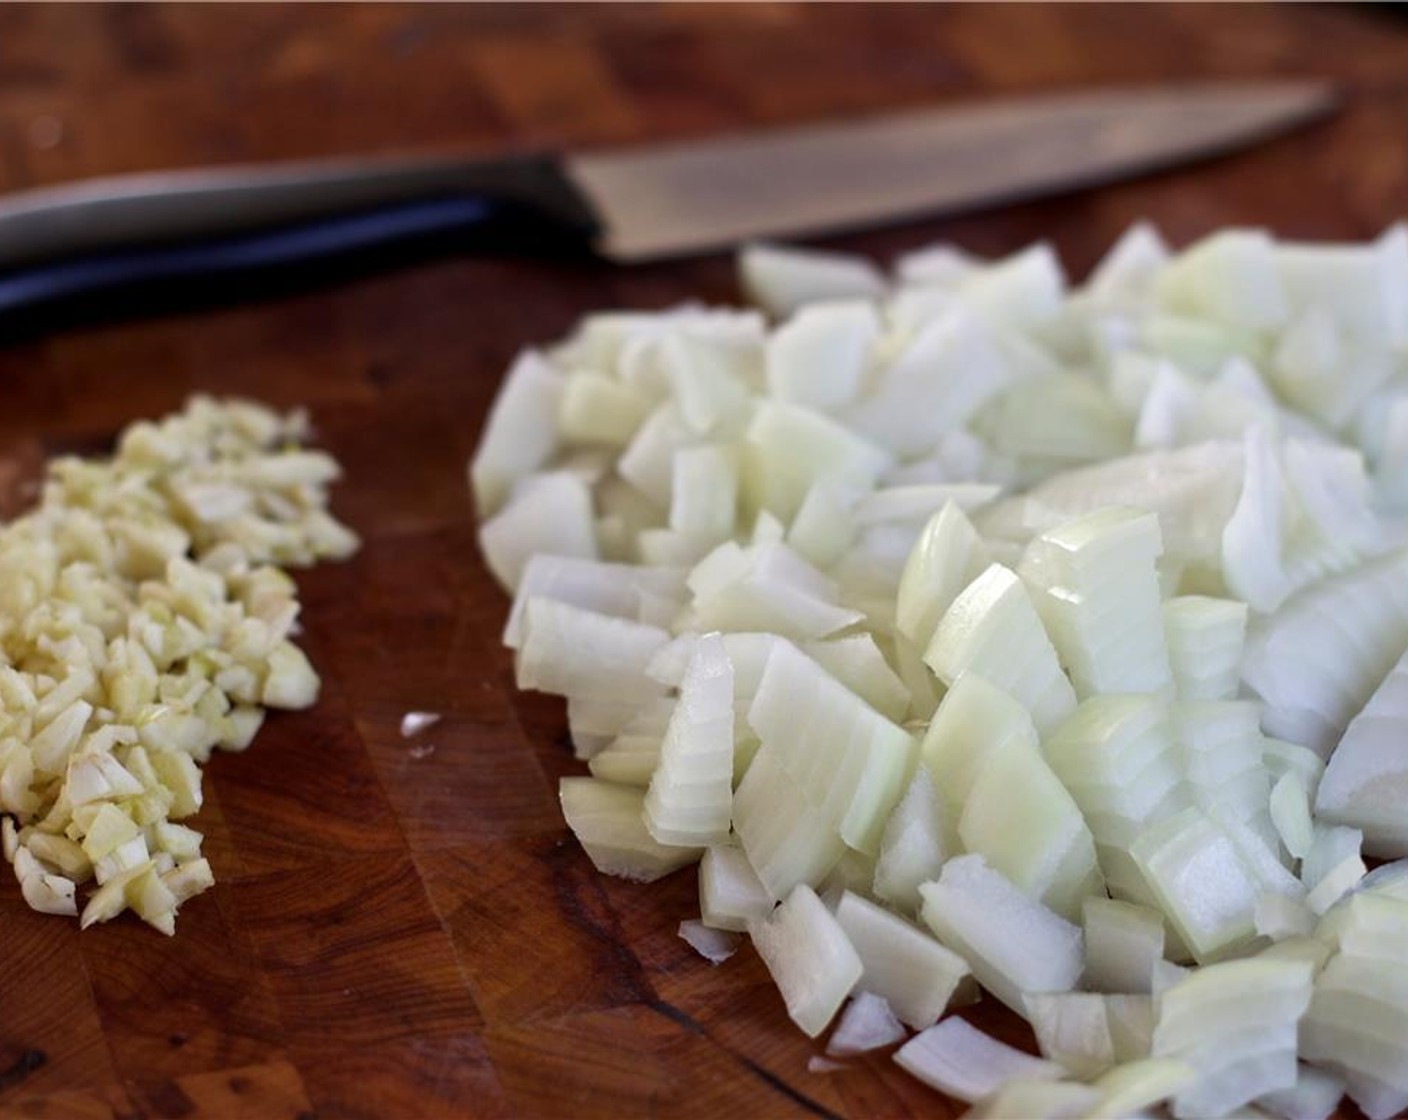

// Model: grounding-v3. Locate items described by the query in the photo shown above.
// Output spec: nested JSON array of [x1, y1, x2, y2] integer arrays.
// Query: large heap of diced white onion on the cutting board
[[470, 225, 1408, 1120]]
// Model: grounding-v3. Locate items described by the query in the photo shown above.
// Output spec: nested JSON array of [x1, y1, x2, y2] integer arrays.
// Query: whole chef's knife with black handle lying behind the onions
[[0, 82, 1333, 325]]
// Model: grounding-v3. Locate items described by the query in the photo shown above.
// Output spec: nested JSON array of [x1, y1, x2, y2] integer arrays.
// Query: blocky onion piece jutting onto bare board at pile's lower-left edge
[[748, 883, 865, 1038]]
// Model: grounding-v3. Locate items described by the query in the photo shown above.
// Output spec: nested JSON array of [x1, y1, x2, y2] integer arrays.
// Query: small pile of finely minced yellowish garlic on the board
[[0, 397, 358, 934]]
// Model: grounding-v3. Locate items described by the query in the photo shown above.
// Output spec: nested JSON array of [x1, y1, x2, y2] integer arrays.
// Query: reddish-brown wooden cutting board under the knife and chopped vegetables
[[0, 4, 1408, 1117]]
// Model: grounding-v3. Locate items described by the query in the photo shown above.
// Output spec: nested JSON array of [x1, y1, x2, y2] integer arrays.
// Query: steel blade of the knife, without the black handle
[[566, 82, 1335, 261]]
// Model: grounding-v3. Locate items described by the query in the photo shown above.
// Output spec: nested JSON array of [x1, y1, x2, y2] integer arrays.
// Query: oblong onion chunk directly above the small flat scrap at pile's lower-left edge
[[836, 890, 969, 1028]]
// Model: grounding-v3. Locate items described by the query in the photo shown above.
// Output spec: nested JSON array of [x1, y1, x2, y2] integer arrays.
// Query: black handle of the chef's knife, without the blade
[[0, 156, 600, 338]]
